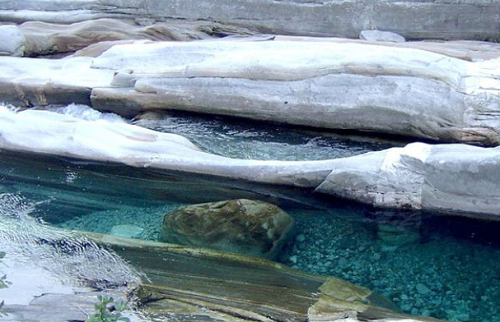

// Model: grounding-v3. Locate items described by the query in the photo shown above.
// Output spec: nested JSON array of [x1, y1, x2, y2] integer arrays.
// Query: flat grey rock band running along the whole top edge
[[0, 0, 500, 40]]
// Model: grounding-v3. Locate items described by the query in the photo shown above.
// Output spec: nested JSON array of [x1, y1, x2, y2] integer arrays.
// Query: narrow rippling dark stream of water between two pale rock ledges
[[134, 112, 404, 161]]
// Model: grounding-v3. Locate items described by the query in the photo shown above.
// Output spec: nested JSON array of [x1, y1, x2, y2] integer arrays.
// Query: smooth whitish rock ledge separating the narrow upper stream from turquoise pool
[[0, 107, 500, 218]]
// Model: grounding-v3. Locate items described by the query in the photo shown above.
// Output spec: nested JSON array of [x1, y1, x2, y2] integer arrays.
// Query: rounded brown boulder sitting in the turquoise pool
[[161, 199, 294, 259]]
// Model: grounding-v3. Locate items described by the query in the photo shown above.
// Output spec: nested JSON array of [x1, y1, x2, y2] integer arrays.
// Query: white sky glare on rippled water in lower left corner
[[0, 191, 139, 307]]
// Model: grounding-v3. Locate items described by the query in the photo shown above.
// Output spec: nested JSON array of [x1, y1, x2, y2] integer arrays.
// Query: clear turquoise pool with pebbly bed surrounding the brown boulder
[[0, 152, 500, 322]]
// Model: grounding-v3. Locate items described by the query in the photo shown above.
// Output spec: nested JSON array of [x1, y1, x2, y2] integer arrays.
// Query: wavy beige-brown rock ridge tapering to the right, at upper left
[[8, 19, 252, 56]]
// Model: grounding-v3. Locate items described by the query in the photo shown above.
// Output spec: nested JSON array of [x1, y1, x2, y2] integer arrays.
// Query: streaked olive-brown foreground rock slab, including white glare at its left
[[0, 209, 434, 322]]
